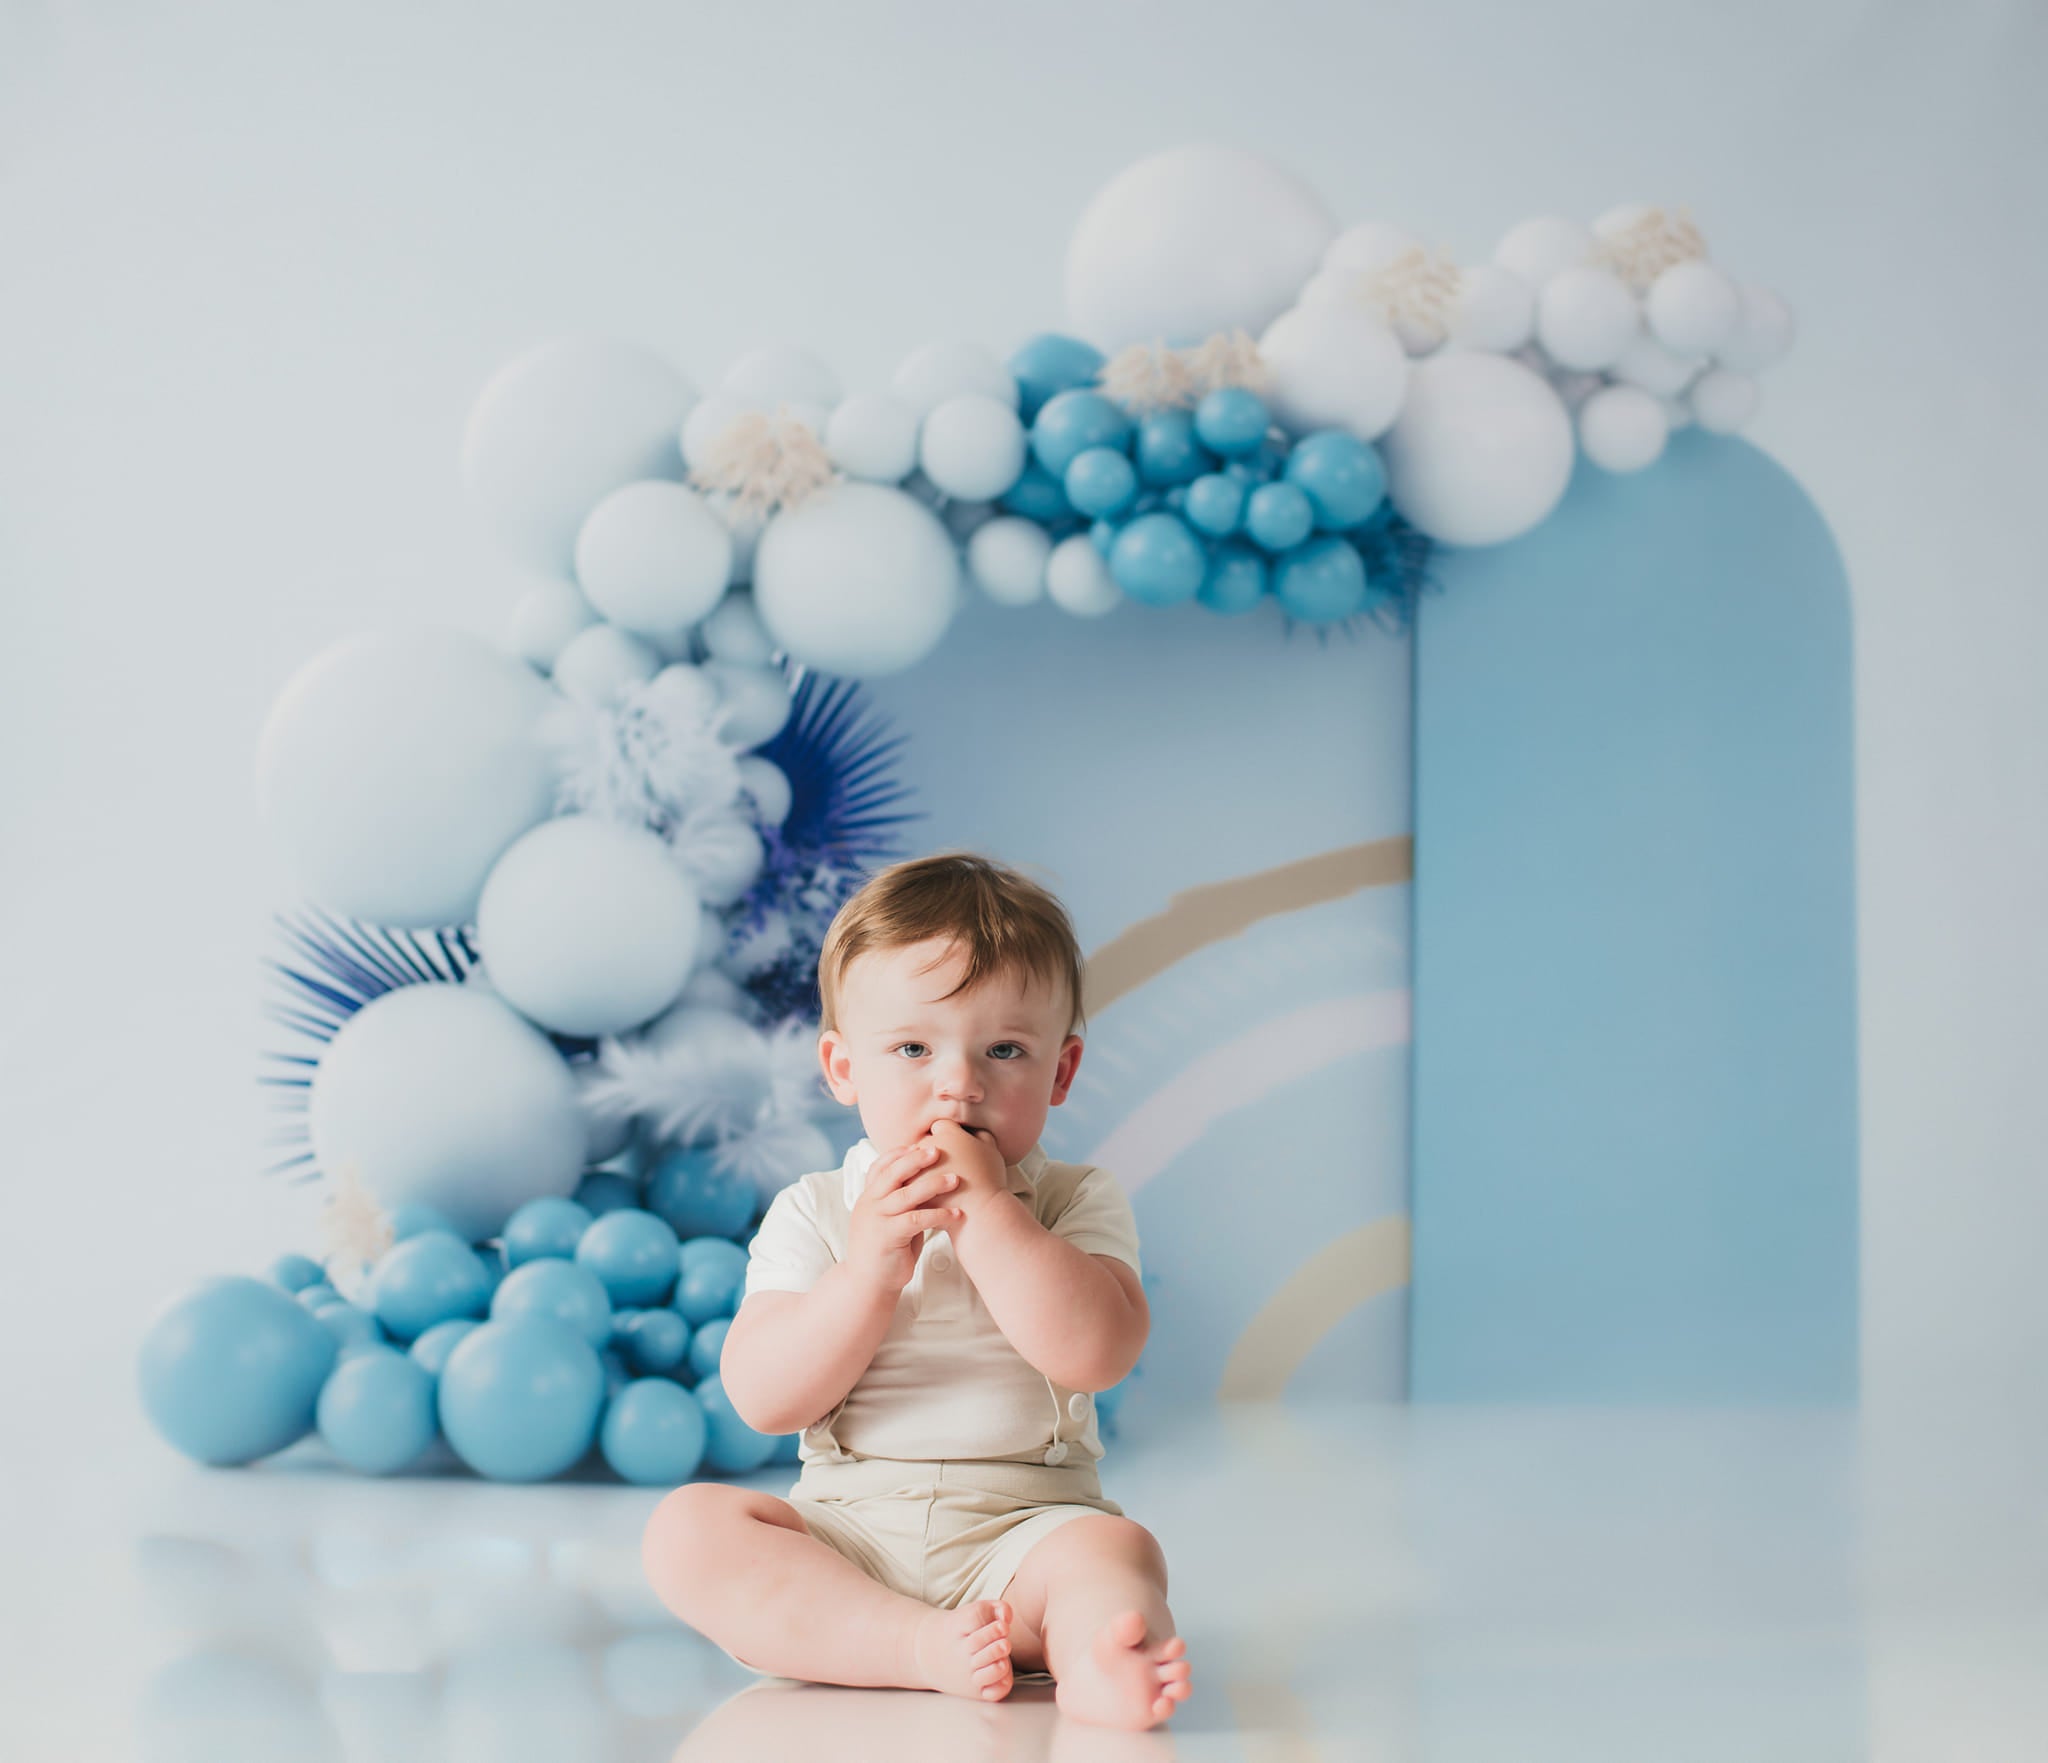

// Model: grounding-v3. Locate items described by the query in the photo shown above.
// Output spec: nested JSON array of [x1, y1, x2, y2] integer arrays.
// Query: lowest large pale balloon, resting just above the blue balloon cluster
[[307, 985, 588, 1243]]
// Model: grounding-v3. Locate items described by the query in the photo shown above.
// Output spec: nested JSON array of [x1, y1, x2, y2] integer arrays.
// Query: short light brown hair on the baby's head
[[817, 850, 1081, 1034]]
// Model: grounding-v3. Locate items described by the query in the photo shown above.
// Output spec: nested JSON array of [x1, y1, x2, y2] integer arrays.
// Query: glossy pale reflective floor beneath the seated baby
[[0, 1407, 2048, 1763]]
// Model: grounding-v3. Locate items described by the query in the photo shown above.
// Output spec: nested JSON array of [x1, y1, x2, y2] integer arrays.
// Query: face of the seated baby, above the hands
[[817, 938, 1081, 1165]]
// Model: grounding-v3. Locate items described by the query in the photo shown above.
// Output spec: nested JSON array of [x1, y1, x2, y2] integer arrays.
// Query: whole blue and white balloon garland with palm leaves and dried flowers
[[139, 147, 1792, 1482]]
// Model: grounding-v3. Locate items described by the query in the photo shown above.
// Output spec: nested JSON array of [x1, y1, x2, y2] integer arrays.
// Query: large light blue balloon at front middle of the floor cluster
[[438, 1310, 604, 1480]]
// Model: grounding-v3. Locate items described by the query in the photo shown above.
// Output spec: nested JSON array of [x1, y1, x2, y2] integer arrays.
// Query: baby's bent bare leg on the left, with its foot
[[641, 1482, 1012, 1700]]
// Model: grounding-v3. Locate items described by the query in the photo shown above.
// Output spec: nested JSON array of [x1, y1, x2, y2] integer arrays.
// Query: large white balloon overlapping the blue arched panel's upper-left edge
[[1380, 350, 1577, 545]]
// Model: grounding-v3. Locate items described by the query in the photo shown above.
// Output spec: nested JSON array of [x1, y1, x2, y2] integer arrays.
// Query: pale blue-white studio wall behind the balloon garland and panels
[[0, 0, 2048, 1448]]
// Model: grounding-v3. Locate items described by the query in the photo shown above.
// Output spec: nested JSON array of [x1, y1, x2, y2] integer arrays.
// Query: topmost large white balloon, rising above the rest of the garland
[[1067, 145, 1337, 352]]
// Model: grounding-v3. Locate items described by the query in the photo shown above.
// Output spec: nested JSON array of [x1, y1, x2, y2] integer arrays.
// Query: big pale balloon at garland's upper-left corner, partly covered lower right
[[463, 336, 696, 573]]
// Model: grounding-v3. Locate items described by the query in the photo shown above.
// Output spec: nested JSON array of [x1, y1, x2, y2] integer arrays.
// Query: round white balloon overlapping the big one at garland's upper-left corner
[[575, 481, 733, 639]]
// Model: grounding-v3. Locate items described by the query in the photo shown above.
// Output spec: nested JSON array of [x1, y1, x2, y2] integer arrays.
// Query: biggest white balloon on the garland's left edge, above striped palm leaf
[[256, 627, 555, 928]]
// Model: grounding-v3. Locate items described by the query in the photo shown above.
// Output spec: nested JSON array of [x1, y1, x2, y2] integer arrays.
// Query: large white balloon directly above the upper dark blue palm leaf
[[754, 481, 961, 680]]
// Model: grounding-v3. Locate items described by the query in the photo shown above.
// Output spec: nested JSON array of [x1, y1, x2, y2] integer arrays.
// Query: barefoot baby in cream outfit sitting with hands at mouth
[[643, 852, 1190, 1728]]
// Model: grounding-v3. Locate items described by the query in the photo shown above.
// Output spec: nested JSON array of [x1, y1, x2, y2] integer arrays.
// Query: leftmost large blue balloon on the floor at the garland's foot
[[135, 1274, 340, 1464]]
